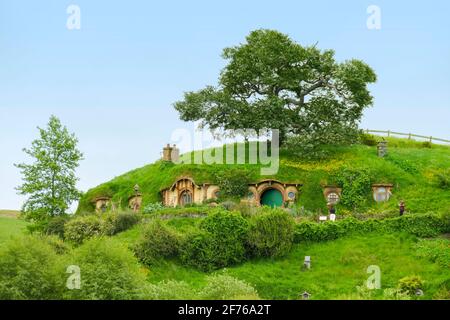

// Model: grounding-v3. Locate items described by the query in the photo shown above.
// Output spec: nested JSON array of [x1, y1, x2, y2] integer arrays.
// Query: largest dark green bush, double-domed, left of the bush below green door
[[181, 210, 248, 271]]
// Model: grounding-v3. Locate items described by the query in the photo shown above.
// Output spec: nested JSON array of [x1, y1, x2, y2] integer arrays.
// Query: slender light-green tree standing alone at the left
[[15, 116, 83, 222]]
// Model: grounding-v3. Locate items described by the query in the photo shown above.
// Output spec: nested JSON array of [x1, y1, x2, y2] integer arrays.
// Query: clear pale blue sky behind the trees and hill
[[0, 0, 450, 208]]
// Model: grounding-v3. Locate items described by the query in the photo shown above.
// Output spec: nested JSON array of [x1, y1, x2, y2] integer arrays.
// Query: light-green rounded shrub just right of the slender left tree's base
[[64, 215, 103, 244]]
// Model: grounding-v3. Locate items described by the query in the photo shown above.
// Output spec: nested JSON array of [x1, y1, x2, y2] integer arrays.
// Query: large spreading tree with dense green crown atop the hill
[[174, 30, 376, 149]]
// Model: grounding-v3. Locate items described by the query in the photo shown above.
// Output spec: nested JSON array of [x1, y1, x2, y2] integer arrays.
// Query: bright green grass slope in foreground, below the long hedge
[[115, 222, 450, 299]]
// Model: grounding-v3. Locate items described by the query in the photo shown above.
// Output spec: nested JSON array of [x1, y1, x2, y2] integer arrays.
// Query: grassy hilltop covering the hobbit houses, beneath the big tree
[[77, 138, 450, 213]]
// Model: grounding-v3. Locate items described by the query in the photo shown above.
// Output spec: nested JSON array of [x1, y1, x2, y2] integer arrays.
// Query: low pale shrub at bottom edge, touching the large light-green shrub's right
[[143, 280, 196, 300]]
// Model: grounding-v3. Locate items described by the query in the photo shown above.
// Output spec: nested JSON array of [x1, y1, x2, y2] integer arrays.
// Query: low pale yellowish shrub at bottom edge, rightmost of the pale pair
[[199, 275, 259, 300]]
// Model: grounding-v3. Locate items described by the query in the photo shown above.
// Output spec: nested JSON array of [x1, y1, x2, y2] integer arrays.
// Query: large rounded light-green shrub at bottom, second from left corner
[[65, 238, 145, 300]]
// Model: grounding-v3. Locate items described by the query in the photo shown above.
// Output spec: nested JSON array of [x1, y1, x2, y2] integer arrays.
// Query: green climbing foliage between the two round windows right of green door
[[336, 168, 371, 209]]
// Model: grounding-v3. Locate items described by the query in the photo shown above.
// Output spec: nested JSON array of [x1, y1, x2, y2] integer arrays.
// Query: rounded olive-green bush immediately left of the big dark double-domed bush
[[133, 220, 181, 265]]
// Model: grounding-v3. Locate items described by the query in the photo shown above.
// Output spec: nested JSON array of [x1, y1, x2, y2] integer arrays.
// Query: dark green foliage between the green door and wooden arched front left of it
[[215, 169, 251, 199]]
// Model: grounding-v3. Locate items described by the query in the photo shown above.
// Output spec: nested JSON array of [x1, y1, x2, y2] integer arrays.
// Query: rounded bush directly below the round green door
[[247, 208, 294, 257]]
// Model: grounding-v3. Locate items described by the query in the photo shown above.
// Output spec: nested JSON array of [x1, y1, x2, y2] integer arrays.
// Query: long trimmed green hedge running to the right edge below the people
[[294, 213, 450, 243]]
